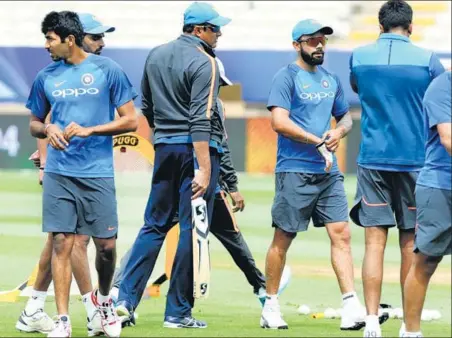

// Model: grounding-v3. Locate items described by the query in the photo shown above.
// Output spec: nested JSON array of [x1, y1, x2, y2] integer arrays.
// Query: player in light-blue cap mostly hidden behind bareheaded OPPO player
[[16, 13, 115, 335]]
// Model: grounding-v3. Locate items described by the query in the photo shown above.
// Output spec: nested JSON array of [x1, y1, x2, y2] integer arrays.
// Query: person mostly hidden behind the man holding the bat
[[112, 57, 290, 326]]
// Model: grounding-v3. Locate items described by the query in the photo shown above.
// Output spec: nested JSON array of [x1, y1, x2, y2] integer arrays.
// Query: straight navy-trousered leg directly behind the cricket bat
[[164, 145, 219, 328]]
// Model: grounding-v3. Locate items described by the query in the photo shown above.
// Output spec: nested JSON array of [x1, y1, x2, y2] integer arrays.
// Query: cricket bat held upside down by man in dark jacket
[[191, 197, 210, 299]]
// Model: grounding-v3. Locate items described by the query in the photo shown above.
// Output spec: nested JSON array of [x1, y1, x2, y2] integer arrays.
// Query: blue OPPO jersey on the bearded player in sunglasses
[[267, 63, 349, 174]]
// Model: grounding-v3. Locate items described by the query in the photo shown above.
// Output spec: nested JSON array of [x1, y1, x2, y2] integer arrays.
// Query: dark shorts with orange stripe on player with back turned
[[350, 166, 418, 230]]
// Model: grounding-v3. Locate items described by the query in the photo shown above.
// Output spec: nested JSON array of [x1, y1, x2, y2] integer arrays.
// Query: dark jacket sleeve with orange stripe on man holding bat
[[189, 56, 219, 142]]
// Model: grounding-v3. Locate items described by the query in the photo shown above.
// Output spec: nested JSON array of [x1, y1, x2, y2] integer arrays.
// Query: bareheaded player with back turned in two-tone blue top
[[350, 0, 444, 337]]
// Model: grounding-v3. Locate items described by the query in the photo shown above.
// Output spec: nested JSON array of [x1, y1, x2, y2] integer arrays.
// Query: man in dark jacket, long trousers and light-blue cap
[[117, 2, 230, 328]]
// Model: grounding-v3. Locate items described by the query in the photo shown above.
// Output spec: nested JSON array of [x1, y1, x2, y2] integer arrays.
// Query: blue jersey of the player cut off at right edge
[[417, 71, 452, 190]]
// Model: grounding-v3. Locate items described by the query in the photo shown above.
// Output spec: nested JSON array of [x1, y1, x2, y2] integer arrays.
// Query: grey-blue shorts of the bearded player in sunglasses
[[272, 172, 348, 233]]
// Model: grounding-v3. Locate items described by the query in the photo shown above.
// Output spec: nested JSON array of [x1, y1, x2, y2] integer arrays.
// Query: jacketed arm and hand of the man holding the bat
[[189, 58, 219, 199]]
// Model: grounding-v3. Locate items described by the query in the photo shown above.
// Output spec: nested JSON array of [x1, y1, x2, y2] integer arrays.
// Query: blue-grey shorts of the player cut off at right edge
[[414, 185, 452, 257]]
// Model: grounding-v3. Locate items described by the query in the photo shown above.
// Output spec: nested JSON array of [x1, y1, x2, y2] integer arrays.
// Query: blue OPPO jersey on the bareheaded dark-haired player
[[26, 54, 137, 177]]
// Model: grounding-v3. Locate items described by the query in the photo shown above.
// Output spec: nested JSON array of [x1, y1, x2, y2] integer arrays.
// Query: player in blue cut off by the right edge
[[400, 71, 452, 337]]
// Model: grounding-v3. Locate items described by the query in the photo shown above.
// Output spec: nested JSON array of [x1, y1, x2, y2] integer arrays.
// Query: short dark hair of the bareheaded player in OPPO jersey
[[41, 11, 84, 47]]
